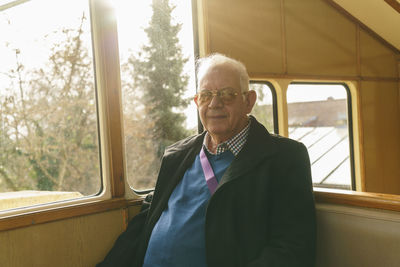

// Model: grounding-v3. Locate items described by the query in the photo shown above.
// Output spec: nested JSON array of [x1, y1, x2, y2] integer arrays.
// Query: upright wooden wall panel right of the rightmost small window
[[360, 81, 400, 194]]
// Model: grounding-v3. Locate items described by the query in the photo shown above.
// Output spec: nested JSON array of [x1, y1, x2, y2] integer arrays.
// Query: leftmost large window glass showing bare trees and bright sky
[[0, 0, 101, 209]]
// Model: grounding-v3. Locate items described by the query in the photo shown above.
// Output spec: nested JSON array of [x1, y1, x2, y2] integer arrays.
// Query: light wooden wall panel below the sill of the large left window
[[0, 209, 124, 267]]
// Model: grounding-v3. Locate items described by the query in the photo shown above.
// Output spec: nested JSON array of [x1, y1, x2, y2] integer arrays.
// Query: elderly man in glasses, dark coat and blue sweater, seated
[[99, 54, 315, 267]]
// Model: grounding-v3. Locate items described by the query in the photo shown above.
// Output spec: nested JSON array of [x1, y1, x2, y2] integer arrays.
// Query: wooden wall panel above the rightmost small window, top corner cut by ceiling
[[284, 0, 357, 76]]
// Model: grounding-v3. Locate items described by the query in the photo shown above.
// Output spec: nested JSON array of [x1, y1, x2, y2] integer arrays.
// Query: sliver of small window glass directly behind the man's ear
[[249, 82, 277, 133]]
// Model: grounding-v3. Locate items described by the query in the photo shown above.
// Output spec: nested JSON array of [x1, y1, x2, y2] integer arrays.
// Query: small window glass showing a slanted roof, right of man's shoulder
[[287, 84, 352, 189]]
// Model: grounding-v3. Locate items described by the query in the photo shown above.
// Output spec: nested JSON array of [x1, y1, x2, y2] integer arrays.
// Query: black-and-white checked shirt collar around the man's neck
[[203, 120, 251, 157]]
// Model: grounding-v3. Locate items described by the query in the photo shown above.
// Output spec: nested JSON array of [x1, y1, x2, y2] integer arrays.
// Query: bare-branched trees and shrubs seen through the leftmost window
[[0, 15, 100, 194]]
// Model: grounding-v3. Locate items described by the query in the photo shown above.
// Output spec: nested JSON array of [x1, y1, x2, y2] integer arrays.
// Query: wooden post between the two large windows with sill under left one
[[0, 0, 134, 231]]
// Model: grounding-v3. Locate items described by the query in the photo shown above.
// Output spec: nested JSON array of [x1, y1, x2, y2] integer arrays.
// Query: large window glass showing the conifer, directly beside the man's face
[[114, 0, 197, 190]]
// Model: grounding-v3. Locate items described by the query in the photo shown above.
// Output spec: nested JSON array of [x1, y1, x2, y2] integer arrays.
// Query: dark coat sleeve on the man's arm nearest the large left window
[[96, 193, 152, 267]]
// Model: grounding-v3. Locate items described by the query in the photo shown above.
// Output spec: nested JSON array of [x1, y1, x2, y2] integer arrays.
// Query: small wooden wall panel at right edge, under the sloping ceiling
[[360, 29, 400, 78]]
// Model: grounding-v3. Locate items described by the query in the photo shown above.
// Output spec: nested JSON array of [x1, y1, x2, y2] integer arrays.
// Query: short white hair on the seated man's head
[[196, 53, 249, 92]]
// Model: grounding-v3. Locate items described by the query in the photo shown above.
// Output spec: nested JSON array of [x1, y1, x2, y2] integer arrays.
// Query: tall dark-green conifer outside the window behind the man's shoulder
[[130, 0, 189, 158]]
